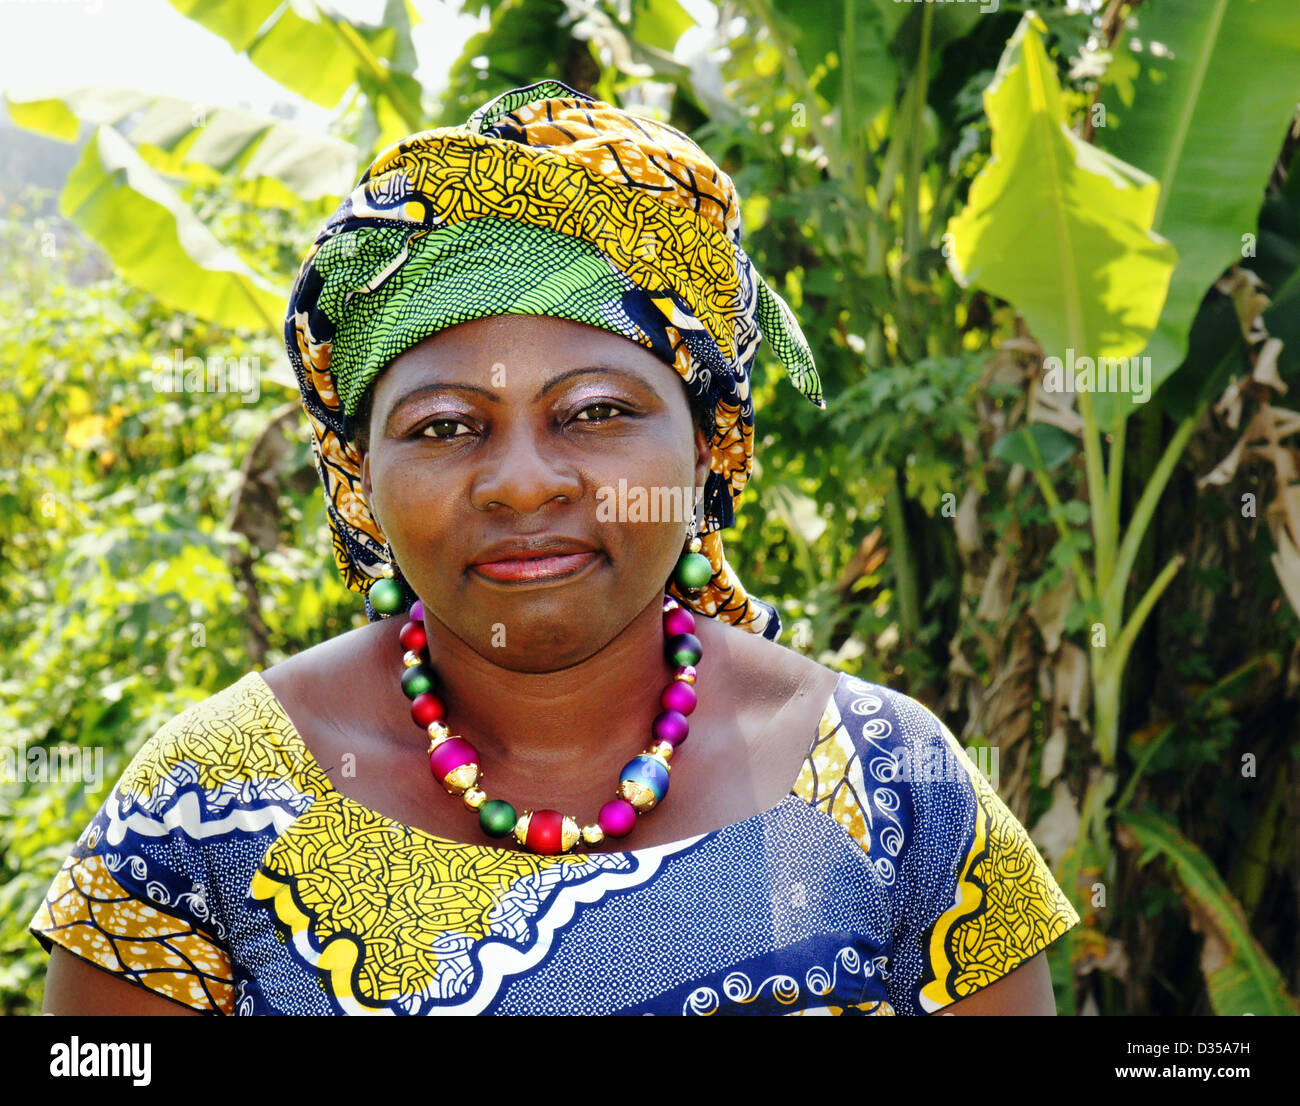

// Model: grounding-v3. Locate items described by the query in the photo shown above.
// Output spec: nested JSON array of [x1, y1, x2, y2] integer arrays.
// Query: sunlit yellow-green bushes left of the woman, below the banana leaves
[[0, 183, 358, 1012]]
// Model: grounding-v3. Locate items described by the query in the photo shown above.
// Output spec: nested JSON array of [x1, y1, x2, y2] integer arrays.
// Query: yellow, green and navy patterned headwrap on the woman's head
[[285, 81, 826, 641]]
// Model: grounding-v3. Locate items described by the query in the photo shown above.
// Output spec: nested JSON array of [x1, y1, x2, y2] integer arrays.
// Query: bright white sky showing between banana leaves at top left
[[0, 0, 488, 129]]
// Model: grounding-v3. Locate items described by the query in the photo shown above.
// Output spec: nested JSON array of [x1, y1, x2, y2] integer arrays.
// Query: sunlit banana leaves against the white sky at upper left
[[5, 0, 426, 334]]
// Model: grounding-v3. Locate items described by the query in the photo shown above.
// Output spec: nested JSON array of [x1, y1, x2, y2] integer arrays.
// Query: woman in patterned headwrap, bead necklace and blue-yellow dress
[[33, 75, 1079, 1014]]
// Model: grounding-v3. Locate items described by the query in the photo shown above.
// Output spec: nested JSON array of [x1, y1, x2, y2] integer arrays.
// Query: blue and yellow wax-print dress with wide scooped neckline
[[31, 672, 1079, 1015]]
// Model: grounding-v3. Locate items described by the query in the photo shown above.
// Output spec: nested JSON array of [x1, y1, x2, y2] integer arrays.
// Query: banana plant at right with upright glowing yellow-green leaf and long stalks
[[948, 0, 1300, 1012]]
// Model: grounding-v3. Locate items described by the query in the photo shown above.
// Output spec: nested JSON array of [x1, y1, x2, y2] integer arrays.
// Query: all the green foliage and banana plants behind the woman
[[0, 0, 1300, 1014]]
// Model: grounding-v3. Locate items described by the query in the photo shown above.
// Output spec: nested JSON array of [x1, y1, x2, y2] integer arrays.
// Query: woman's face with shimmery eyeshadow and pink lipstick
[[361, 315, 709, 672]]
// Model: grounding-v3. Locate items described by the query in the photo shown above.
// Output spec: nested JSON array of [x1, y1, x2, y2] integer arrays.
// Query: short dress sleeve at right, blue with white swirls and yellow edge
[[797, 676, 1080, 1014]]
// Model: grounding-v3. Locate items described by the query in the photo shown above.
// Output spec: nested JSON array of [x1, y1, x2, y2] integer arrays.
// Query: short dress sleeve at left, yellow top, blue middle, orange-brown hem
[[29, 672, 304, 1014]]
